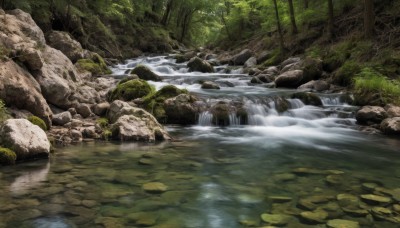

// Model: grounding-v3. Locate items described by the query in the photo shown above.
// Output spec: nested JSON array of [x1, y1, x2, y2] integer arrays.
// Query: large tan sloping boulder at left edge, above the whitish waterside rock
[[0, 61, 53, 128]]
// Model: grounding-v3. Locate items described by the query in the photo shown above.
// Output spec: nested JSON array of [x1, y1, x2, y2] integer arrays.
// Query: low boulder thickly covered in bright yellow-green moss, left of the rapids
[[110, 79, 153, 101]]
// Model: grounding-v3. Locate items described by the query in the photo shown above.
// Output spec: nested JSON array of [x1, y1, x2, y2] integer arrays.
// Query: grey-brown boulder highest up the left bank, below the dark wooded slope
[[47, 31, 88, 63]]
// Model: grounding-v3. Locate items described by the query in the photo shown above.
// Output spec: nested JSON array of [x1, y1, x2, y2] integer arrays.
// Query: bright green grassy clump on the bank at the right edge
[[354, 67, 400, 105]]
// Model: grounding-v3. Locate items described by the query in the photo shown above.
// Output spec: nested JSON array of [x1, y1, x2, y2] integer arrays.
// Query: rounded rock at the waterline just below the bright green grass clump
[[356, 106, 387, 124]]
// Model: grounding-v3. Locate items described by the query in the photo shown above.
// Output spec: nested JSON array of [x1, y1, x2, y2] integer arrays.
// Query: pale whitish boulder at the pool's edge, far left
[[0, 119, 50, 160]]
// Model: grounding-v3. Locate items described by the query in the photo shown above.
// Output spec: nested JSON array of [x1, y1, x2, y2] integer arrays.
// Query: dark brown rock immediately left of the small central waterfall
[[164, 94, 200, 125]]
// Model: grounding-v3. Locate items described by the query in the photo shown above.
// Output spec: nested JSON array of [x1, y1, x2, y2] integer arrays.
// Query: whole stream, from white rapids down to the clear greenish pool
[[0, 56, 400, 228]]
